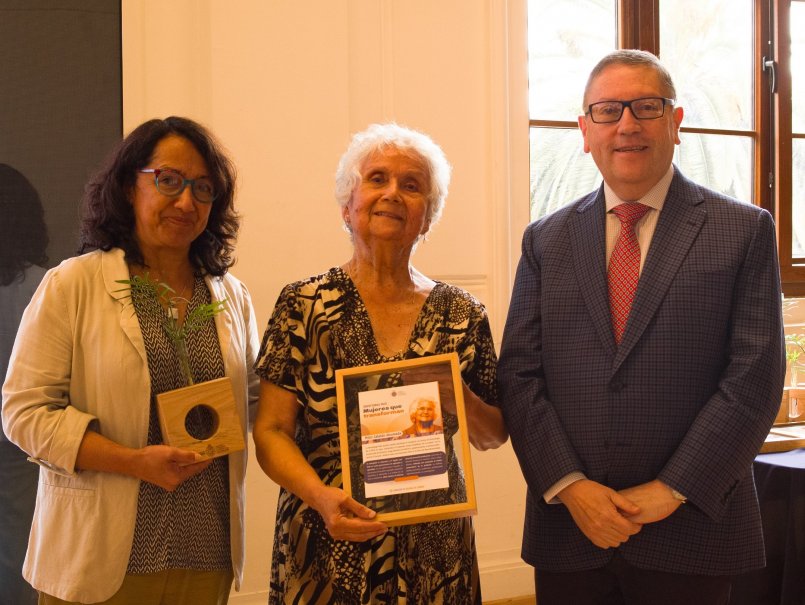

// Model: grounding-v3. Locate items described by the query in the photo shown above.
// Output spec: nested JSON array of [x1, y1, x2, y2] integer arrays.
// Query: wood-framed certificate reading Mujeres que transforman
[[335, 353, 476, 525]]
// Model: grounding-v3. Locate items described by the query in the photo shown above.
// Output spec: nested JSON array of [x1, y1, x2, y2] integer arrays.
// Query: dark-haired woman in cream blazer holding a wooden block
[[3, 117, 259, 605]]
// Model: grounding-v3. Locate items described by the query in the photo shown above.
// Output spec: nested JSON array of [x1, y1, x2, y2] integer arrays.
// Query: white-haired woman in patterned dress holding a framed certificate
[[254, 124, 507, 605]]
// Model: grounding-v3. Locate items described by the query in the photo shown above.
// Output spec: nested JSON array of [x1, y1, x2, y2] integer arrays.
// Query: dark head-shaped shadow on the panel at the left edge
[[0, 164, 48, 286]]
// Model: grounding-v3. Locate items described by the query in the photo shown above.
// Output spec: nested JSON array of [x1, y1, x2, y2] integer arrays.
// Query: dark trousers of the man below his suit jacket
[[535, 551, 732, 605]]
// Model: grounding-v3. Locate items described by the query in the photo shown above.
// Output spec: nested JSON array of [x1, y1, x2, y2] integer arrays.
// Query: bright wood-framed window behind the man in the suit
[[528, 0, 805, 295]]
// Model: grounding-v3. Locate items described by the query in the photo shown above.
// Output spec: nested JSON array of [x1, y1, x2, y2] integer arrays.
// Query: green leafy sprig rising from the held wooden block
[[115, 272, 227, 385]]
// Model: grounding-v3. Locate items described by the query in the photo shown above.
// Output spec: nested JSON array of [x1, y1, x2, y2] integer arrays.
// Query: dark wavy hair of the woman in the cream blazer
[[79, 116, 240, 276]]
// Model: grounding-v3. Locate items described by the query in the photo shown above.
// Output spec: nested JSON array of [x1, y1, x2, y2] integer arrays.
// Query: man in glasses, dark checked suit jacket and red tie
[[498, 50, 785, 605]]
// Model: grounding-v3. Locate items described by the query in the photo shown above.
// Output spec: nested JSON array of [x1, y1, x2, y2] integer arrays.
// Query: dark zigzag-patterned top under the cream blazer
[[127, 277, 232, 574]]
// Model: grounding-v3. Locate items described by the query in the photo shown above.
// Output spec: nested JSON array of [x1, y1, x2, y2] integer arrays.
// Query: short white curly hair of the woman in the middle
[[335, 122, 451, 227]]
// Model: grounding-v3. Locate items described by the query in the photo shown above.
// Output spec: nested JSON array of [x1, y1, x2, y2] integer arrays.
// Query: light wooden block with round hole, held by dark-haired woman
[[157, 377, 246, 458]]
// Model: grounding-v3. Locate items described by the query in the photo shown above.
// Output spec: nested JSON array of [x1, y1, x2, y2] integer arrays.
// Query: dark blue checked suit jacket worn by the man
[[498, 169, 785, 574]]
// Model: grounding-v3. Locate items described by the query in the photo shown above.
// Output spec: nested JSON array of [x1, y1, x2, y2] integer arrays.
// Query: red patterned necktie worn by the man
[[607, 202, 649, 343]]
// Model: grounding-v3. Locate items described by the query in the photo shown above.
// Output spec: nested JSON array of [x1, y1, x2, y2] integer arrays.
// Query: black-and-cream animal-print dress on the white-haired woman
[[256, 268, 497, 605]]
